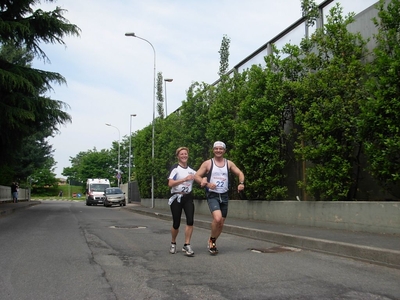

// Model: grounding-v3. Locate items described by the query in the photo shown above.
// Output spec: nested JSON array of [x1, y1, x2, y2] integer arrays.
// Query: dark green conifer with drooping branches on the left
[[0, 0, 79, 180]]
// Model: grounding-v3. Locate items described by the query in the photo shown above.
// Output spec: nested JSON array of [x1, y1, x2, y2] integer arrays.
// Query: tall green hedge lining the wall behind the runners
[[134, 0, 400, 201]]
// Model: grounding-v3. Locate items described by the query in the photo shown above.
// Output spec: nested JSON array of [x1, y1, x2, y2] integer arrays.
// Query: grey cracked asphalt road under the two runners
[[0, 201, 400, 300]]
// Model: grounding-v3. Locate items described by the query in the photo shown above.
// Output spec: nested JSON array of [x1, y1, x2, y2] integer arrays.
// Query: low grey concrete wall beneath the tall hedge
[[141, 199, 400, 234]]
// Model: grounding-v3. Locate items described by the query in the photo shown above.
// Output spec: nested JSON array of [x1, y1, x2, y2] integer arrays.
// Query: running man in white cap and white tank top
[[194, 141, 244, 255]]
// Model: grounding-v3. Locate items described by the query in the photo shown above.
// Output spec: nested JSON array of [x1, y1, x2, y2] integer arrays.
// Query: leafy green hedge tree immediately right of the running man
[[235, 49, 291, 200]]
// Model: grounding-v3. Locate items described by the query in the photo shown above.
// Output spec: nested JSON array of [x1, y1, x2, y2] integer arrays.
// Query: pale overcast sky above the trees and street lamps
[[33, 0, 375, 177]]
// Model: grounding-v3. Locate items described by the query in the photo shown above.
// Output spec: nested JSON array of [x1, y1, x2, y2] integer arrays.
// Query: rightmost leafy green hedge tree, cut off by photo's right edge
[[359, 0, 400, 197]]
